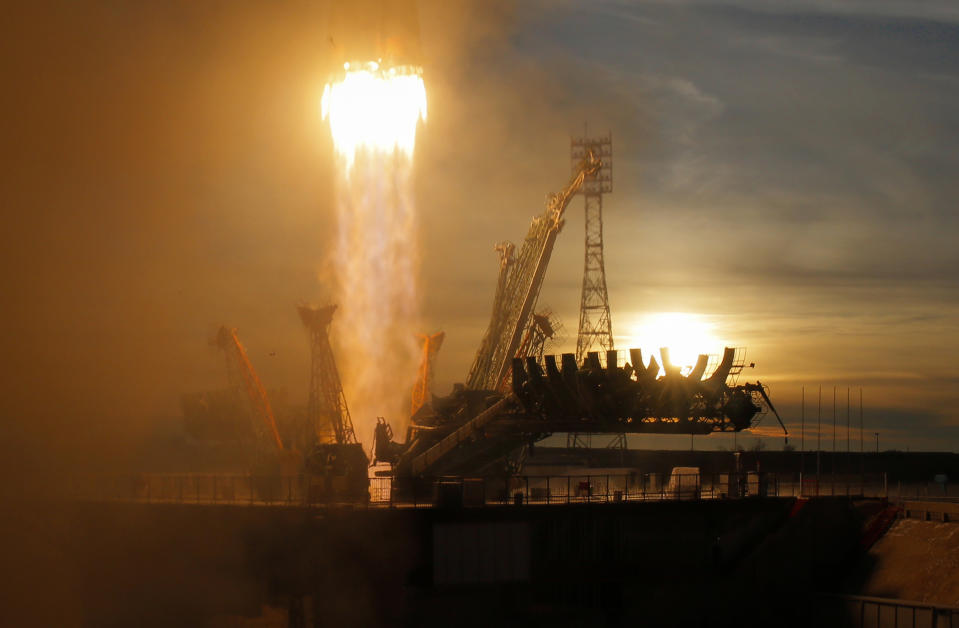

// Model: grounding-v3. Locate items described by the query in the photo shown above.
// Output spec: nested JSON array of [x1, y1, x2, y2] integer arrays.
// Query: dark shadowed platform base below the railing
[[0, 497, 924, 628]]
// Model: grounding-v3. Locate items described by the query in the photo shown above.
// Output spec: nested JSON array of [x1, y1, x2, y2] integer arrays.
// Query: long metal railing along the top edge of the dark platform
[[37, 472, 888, 507]]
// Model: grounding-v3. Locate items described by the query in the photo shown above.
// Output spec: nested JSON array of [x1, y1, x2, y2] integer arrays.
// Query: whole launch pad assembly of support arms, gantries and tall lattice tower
[[188, 130, 786, 502]]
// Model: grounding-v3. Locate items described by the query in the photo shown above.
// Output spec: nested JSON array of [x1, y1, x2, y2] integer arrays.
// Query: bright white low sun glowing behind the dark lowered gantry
[[623, 312, 726, 375]]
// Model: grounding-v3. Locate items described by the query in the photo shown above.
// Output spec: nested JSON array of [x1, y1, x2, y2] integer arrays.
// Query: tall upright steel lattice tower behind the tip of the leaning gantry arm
[[570, 134, 614, 364]]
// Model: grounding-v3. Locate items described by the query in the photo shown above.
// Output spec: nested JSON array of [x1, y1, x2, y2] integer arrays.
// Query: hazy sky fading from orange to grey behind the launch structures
[[0, 0, 959, 468]]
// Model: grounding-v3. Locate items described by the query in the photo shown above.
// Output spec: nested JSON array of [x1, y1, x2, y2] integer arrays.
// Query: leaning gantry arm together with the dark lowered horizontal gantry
[[374, 147, 785, 482]]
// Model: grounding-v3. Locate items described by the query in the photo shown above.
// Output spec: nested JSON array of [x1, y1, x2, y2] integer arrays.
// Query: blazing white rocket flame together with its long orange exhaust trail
[[322, 62, 426, 441]]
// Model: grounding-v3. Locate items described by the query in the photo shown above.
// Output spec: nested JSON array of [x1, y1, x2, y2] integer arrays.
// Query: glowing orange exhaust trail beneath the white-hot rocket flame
[[330, 151, 420, 442]]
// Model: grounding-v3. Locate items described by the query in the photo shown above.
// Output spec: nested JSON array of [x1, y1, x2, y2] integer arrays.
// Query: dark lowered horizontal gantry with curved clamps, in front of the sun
[[386, 348, 785, 477]]
